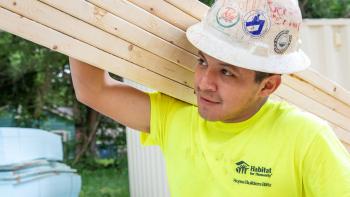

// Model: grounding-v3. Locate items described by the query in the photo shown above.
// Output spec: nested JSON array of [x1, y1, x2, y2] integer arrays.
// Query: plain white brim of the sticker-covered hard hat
[[186, 22, 311, 74]]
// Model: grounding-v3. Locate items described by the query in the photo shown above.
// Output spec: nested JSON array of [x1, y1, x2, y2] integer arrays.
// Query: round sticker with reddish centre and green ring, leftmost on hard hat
[[216, 6, 240, 28]]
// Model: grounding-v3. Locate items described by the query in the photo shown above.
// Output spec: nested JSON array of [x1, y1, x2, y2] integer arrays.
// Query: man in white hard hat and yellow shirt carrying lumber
[[70, 0, 350, 197]]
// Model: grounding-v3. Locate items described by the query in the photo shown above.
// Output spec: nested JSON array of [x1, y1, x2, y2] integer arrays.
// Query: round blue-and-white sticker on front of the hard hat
[[243, 10, 270, 38]]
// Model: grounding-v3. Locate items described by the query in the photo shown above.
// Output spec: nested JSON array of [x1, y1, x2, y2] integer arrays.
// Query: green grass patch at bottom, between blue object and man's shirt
[[79, 158, 130, 197]]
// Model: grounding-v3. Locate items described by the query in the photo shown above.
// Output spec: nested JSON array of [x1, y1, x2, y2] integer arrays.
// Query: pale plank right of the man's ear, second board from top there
[[282, 75, 350, 118]]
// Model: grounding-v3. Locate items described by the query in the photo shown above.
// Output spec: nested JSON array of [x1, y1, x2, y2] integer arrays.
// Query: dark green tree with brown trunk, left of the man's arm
[[0, 32, 124, 163]]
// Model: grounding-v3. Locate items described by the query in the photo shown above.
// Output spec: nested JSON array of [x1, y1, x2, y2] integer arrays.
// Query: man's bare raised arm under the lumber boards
[[69, 58, 151, 132]]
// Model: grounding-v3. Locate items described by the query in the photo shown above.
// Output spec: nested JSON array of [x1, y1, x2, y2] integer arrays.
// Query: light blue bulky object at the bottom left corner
[[0, 128, 81, 197]]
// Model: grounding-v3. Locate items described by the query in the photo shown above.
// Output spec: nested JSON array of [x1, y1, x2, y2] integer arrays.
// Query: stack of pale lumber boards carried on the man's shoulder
[[0, 0, 350, 151]]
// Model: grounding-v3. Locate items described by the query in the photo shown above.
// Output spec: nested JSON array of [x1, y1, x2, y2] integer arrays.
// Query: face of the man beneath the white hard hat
[[195, 52, 261, 122]]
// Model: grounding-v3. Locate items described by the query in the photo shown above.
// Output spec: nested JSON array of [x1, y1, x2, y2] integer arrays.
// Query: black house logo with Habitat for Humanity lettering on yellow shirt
[[236, 161, 272, 178]]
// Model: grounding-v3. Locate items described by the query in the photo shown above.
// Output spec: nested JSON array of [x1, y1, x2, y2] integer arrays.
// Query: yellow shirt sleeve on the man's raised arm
[[140, 92, 176, 149]]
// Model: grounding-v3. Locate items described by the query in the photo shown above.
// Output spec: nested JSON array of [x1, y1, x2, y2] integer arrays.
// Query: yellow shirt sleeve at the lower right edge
[[303, 125, 350, 197]]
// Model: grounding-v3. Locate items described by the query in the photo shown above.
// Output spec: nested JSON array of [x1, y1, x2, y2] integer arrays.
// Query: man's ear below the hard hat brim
[[259, 74, 282, 97]]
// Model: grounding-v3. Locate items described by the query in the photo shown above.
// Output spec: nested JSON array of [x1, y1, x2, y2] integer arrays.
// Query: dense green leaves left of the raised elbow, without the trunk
[[0, 32, 73, 128]]
